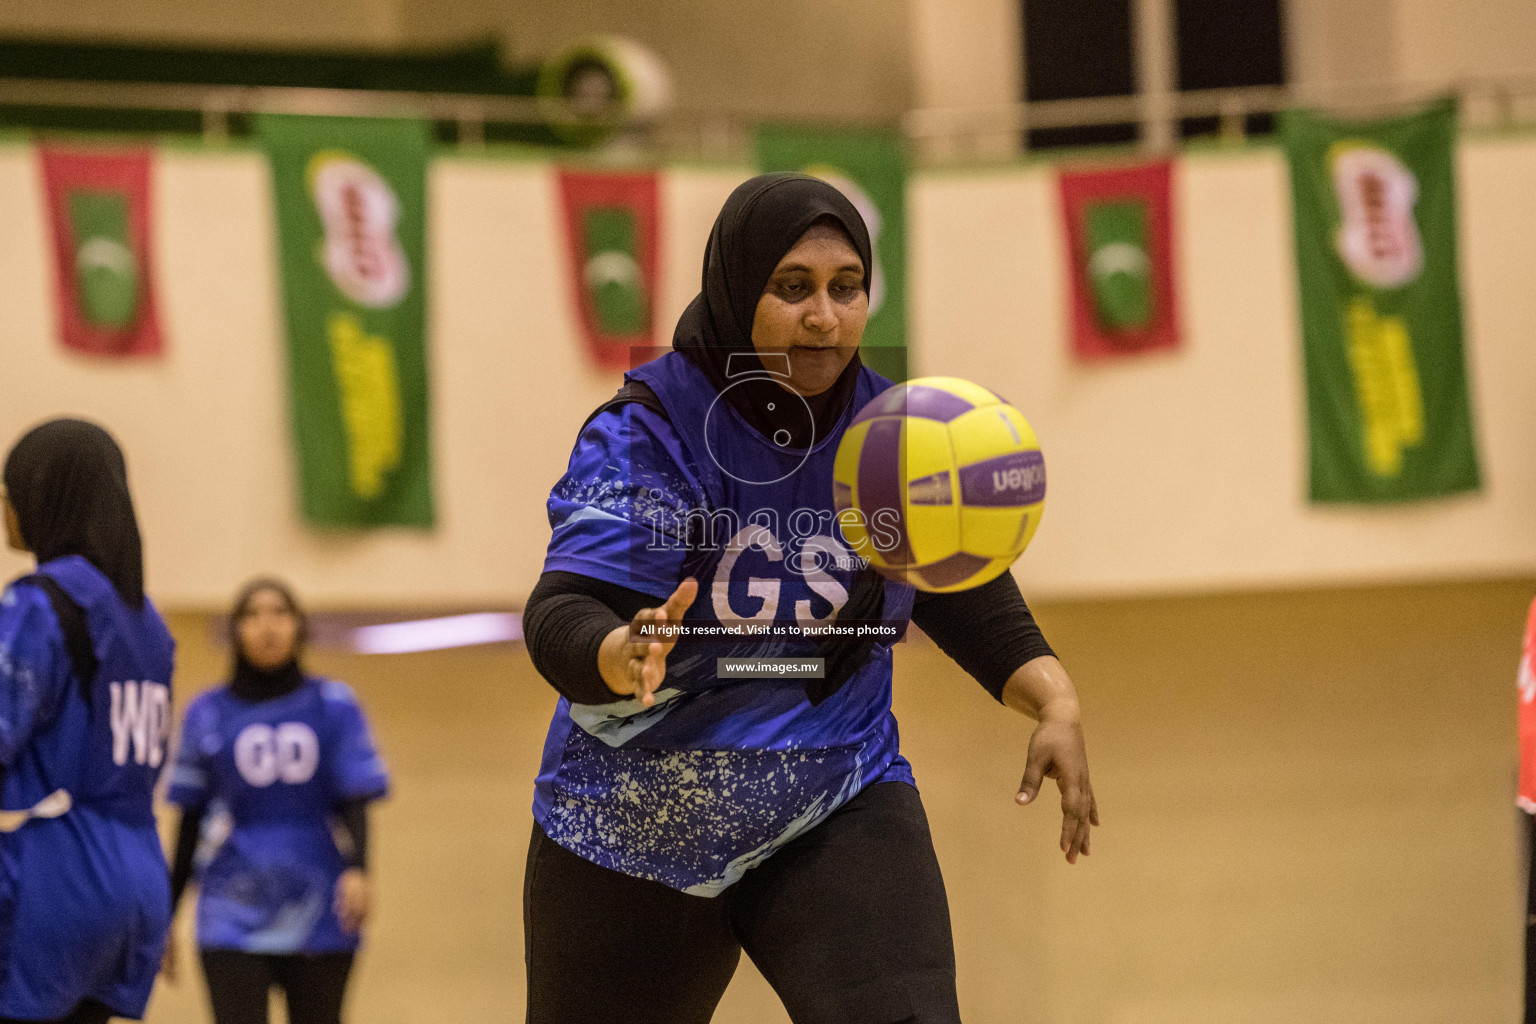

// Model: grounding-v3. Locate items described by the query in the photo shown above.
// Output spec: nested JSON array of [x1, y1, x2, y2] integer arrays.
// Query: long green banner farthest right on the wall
[[1281, 101, 1479, 502]]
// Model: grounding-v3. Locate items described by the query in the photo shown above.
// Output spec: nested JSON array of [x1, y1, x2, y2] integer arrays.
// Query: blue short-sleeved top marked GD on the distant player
[[167, 679, 389, 953]]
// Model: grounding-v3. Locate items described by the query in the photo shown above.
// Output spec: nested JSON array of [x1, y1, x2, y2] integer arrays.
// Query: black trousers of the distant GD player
[[203, 949, 353, 1024]]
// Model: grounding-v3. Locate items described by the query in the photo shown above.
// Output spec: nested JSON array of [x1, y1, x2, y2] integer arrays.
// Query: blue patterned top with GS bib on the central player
[[535, 353, 912, 895]]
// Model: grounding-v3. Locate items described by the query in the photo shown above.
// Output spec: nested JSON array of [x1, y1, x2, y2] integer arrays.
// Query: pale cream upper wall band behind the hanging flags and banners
[[0, 138, 1536, 606]]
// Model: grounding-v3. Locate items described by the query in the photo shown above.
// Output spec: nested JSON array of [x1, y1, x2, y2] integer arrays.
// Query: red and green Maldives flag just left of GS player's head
[[559, 170, 657, 370]]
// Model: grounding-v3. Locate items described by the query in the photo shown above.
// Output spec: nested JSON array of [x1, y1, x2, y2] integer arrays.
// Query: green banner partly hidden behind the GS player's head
[[757, 126, 908, 381]]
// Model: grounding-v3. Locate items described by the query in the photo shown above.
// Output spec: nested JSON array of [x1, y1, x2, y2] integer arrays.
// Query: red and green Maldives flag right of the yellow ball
[[1060, 161, 1180, 359]]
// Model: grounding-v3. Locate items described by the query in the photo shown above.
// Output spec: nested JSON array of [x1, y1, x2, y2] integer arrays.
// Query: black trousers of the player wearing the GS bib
[[525, 783, 960, 1024]]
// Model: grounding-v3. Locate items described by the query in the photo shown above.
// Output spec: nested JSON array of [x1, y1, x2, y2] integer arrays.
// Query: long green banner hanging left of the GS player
[[255, 115, 433, 527]]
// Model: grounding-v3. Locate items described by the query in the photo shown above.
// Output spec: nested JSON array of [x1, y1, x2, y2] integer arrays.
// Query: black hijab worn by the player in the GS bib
[[673, 173, 874, 448]]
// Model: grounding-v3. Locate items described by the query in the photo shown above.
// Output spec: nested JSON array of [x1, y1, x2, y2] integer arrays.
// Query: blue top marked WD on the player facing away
[[0, 556, 175, 1019]]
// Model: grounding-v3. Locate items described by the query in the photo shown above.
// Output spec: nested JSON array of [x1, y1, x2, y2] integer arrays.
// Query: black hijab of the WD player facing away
[[5, 419, 144, 608]]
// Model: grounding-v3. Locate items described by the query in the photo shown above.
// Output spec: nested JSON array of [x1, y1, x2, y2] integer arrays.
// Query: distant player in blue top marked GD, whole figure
[[167, 580, 389, 1024]]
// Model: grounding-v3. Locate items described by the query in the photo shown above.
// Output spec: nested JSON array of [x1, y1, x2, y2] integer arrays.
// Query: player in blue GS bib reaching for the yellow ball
[[524, 175, 1097, 1024]]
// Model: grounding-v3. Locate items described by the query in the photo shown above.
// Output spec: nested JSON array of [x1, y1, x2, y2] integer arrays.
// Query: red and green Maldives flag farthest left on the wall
[[38, 146, 161, 356]]
